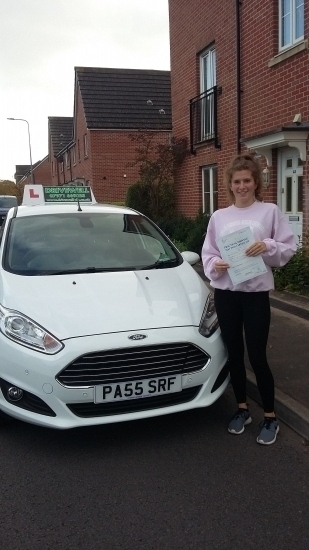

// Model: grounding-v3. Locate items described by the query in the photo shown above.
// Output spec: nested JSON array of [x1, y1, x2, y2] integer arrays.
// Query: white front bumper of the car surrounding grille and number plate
[[0, 327, 228, 429]]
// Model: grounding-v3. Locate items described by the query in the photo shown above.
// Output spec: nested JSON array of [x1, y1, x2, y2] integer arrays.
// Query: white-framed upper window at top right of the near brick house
[[279, 0, 304, 49]]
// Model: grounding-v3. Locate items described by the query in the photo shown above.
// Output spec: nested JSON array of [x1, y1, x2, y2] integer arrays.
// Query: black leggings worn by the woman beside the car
[[215, 288, 275, 413]]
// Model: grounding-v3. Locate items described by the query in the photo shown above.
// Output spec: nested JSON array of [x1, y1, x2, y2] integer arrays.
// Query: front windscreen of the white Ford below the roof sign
[[3, 212, 182, 276]]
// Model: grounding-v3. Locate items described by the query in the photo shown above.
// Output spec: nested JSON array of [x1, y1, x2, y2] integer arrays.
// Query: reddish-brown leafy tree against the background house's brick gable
[[126, 131, 188, 221]]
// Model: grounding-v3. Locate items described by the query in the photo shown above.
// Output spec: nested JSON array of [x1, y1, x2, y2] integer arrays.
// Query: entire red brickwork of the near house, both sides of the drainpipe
[[169, 0, 309, 229]]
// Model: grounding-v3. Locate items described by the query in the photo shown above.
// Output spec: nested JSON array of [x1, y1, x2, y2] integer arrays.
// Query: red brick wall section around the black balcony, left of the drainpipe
[[169, 0, 237, 216]]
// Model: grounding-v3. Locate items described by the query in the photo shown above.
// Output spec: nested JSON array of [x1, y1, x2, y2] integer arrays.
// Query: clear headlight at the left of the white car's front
[[0, 306, 64, 355]]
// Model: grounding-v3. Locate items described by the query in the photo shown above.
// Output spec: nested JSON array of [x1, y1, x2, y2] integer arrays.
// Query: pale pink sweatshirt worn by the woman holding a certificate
[[202, 201, 296, 292]]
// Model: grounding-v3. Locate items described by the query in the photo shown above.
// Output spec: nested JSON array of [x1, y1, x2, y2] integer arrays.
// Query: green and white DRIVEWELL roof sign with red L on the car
[[23, 189, 96, 205]]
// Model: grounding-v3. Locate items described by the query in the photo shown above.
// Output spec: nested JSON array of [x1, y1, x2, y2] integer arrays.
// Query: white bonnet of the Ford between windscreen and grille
[[0, 262, 209, 340]]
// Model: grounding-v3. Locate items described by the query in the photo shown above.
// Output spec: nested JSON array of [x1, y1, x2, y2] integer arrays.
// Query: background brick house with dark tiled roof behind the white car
[[53, 67, 171, 202]]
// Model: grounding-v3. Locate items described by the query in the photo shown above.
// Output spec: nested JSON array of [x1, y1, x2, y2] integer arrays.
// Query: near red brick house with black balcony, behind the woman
[[169, 0, 309, 243]]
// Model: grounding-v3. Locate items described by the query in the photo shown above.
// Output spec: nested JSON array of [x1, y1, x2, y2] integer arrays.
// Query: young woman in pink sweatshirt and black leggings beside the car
[[202, 155, 296, 445]]
